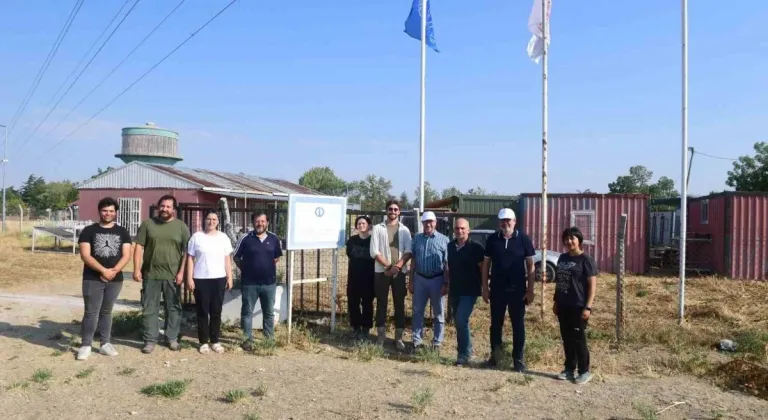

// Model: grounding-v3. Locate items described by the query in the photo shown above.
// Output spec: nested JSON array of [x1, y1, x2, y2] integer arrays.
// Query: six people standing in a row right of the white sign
[[346, 200, 598, 384]]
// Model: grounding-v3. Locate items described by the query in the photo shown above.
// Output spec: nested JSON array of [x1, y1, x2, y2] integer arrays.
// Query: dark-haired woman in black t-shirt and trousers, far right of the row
[[552, 227, 597, 385]]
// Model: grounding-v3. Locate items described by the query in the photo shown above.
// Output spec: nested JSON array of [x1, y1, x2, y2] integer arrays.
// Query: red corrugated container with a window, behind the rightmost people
[[517, 194, 649, 273]]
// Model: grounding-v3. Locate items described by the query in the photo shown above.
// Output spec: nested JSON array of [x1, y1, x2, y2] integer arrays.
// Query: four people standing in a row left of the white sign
[[77, 195, 282, 360]]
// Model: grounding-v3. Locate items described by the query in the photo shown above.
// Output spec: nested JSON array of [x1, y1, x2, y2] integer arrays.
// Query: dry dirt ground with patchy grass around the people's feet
[[0, 230, 768, 420]]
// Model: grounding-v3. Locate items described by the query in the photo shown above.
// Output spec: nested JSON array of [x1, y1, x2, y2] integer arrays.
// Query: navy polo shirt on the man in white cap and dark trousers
[[485, 229, 536, 293]]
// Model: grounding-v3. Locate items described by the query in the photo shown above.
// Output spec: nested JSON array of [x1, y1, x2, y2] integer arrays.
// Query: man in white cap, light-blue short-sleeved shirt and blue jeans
[[408, 211, 449, 349]]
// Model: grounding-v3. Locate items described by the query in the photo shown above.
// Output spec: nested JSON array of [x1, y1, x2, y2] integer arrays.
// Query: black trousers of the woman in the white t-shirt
[[194, 277, 227, 344]]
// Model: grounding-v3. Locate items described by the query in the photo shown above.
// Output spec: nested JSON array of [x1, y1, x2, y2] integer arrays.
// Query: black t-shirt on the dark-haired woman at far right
[[555, 253, 597, 308]]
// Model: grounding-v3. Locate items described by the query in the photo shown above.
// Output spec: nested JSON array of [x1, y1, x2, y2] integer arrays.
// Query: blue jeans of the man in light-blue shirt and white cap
[[411, 274, 445, 346]]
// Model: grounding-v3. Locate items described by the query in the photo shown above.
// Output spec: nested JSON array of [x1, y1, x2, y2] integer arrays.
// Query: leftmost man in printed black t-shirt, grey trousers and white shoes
[[77, 197, 131, 360]]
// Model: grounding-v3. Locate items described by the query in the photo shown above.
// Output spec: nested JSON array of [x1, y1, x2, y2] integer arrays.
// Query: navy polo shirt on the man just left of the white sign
[[235, 231, 283, 286]]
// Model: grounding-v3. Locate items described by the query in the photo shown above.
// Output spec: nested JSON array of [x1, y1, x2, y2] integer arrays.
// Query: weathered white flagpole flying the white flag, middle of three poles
[[539, 0, 549, 319]]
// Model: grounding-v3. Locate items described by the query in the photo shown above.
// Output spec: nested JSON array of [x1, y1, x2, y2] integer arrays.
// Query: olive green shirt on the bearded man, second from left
[[136, 218, 189, 280]]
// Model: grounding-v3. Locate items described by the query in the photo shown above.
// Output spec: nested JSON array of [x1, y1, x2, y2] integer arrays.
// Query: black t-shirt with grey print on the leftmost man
[[78, 223, 131, 281]]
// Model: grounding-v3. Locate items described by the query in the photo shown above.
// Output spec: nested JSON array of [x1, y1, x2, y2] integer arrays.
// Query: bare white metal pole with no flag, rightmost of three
[[677, 0, 688, 325]]
